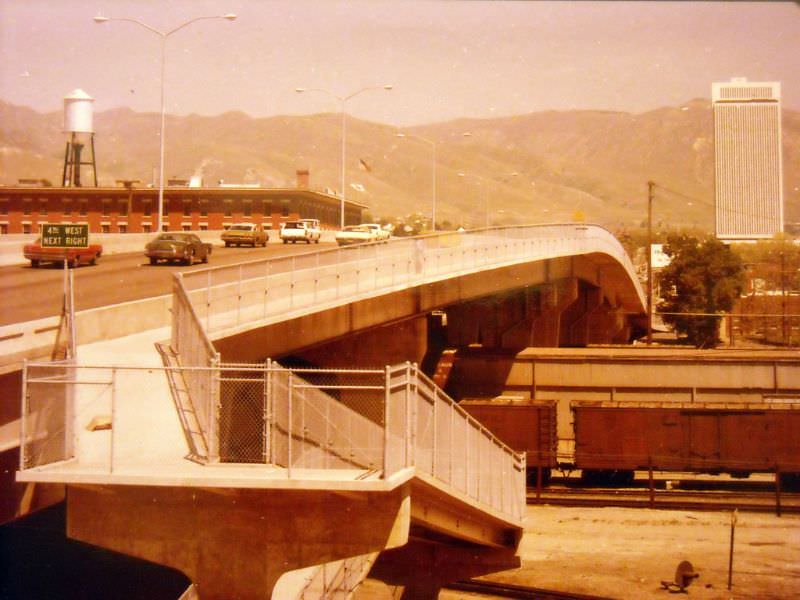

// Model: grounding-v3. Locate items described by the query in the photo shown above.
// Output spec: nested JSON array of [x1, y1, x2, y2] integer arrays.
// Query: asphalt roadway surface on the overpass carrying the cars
[[0, 242, 336, 326]]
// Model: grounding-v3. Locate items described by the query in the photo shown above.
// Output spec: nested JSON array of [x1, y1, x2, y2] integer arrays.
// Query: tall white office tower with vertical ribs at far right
[[711, 78, 783, 240]]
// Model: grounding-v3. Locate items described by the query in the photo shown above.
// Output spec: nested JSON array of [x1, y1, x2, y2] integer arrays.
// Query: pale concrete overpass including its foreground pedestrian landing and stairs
[[12, 224, 644, 599]]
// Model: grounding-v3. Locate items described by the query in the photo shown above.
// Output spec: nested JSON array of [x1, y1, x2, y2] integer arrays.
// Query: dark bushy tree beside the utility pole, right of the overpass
[[658, 235, 744, 348]]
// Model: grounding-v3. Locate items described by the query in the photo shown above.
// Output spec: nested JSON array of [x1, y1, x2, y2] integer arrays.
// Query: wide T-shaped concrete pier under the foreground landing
[[67, 485, 410, 600]]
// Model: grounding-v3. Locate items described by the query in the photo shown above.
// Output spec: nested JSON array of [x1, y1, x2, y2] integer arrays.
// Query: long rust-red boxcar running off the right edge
[[571, 401, 800, 484]]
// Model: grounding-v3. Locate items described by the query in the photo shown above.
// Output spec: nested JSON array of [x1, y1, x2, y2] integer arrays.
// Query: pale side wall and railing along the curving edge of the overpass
[[181, 223, 644, 335]]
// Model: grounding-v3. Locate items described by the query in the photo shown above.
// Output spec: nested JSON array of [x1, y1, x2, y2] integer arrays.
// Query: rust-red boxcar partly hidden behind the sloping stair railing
[[459, 396, 558, 484]]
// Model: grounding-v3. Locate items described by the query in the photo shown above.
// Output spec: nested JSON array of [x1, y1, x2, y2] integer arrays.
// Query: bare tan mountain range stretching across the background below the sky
[[0, 99, 800, 231]]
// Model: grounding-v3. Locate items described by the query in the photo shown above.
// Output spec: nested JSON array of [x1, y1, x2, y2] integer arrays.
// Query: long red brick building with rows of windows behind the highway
[[0, 173, 366, 234]]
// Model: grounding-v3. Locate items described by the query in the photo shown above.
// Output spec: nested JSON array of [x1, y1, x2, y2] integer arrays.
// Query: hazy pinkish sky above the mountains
[[0, 0, 800, 125]]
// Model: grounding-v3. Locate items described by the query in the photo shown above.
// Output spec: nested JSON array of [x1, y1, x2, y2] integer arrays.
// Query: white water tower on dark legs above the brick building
[[61, 89, 97, 187]]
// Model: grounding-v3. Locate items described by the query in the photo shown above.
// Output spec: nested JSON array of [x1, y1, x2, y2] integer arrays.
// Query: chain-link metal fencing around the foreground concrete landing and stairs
[[21, 362, 525, 521]]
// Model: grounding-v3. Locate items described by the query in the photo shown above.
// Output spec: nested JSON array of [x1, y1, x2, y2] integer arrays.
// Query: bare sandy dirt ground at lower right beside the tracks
[[357, 506, 800, 600]]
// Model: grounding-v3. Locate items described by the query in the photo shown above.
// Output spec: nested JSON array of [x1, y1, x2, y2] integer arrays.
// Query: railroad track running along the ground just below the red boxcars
[[527, 487, 800, 513]]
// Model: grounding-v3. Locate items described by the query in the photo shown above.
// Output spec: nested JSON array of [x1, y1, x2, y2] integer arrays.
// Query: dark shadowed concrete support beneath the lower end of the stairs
[[370, 539, 520, 600]]
